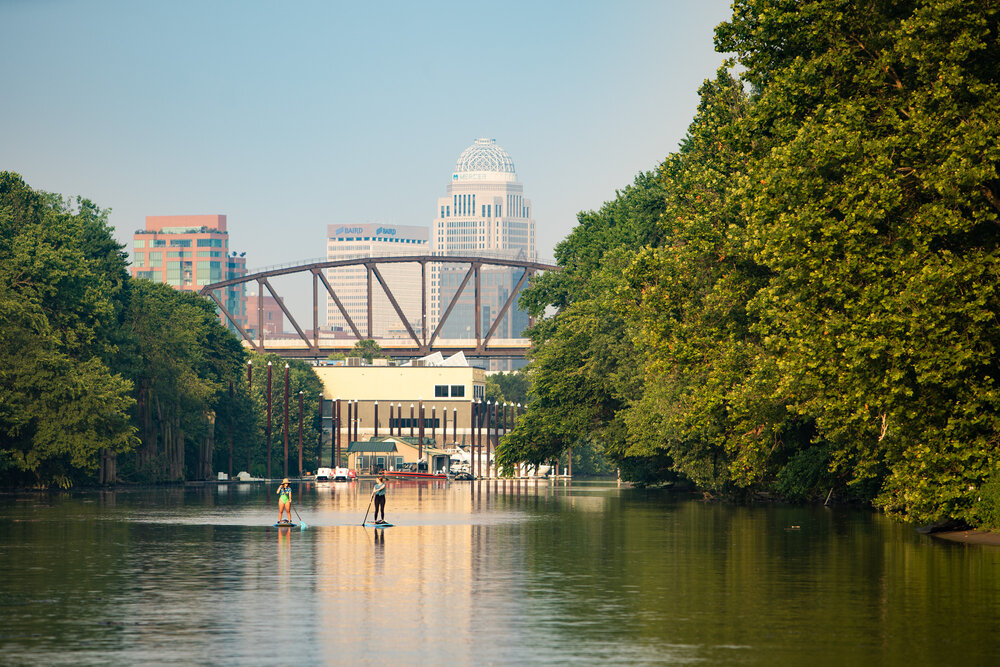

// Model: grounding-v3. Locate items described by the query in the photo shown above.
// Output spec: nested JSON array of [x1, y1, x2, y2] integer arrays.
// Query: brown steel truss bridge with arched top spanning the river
[[199, 255, 560, 357]]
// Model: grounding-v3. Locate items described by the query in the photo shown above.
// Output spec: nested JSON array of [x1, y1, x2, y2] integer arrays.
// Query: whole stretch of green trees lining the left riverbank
[[0, 172, 321, 486]]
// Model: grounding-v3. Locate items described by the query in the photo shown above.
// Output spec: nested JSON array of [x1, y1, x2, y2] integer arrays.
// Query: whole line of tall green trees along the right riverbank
[[500, 0, 1000, 527]]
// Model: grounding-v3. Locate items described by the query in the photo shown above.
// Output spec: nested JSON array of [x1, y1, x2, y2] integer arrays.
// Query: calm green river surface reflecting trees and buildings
[[0, 481, 1000, 667]]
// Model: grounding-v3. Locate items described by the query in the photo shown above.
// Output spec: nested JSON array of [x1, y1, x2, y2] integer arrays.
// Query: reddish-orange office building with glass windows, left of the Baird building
[[131, 215, 247, 331]]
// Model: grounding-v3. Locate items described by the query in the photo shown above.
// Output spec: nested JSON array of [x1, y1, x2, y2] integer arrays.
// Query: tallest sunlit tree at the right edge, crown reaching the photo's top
[[717, 0, 1000, 522]]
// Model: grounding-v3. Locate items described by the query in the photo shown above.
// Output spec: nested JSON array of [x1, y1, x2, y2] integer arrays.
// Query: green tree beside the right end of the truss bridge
[[498, 173, 663, 468]]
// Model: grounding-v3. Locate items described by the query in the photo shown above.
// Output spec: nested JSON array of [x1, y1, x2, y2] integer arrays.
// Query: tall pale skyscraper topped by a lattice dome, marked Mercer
[[428, 139, 537, 350]]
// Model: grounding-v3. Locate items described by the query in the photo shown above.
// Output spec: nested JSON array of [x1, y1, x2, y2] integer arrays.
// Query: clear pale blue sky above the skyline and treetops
[[0, 0, 730, 268]]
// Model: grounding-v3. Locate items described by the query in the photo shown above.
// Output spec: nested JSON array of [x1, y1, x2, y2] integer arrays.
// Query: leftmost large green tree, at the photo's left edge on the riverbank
[[0, 172, 136, 486]]
